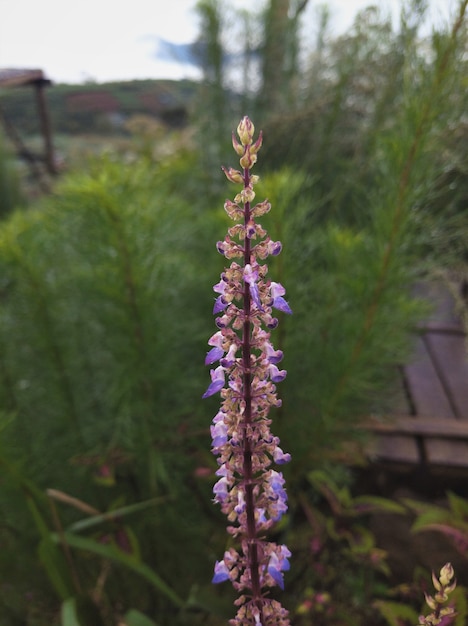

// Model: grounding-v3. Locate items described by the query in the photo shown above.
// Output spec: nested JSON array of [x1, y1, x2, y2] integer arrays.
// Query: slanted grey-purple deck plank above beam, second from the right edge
[[404, 337, 455, 418]]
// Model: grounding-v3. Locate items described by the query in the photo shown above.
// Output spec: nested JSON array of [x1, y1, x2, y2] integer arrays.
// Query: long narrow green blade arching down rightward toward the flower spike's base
[[52, 532, 184, 608]]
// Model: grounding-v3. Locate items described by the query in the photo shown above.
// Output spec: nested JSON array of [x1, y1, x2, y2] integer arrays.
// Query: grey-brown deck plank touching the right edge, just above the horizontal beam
[[425, 333, 468, 420]]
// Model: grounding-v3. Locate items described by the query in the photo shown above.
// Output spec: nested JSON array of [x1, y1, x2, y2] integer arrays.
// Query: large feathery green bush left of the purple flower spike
[[0, 150, 225, 615]]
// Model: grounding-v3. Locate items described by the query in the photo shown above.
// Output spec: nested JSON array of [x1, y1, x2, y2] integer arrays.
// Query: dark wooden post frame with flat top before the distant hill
[[0, 69, 57, 180]]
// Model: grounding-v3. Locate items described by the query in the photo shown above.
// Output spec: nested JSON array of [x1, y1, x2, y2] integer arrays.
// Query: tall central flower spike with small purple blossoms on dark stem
[[203, 117, 291, 626]]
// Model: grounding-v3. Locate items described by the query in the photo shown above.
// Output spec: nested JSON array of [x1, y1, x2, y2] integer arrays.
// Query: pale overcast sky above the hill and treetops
[[0, 0, 457, 83]]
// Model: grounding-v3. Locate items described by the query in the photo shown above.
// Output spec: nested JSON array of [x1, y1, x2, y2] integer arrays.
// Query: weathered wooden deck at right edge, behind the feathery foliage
[[370, 284, 468, 470]]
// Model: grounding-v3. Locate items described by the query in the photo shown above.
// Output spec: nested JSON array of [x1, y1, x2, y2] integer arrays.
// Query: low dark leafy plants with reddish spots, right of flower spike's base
[[288, 470, 405, 624]]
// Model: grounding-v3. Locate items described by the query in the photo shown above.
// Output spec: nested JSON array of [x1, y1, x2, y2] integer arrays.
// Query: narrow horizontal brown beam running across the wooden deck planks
[[365, 415, 468, 436]]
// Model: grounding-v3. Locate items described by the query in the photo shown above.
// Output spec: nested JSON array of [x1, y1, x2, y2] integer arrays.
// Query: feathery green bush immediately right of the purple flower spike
[[252, 170, 423, 468]]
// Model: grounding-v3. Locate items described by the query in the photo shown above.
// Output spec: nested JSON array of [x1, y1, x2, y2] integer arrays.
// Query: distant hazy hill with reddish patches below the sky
[[0, 80, 198, 135]]
